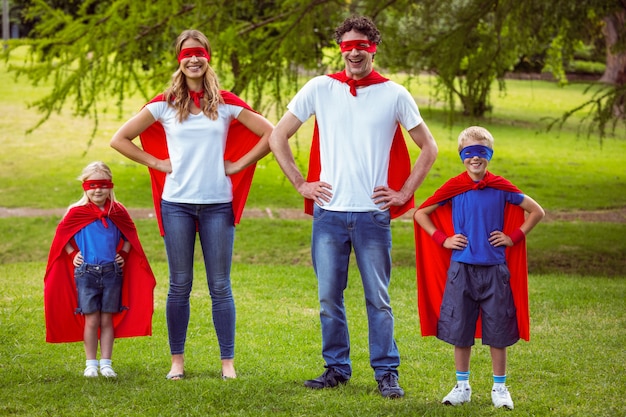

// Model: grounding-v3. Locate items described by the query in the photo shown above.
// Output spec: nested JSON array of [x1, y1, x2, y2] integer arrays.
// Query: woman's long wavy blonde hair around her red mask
[[163, 29, 224, 122]]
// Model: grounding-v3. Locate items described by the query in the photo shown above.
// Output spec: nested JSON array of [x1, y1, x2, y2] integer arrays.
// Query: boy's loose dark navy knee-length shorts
[[437, 261, 519, 348]]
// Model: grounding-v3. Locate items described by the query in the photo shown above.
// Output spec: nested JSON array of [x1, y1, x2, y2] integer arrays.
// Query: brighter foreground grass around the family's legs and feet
[[0, 261, 626, 416]]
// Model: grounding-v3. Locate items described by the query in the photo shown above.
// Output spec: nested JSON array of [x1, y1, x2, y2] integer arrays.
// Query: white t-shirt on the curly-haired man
[[287, 75, 423, 212]]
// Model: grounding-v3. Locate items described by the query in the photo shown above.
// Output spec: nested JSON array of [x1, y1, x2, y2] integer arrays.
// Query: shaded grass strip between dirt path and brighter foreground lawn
[[0, 217, 626, 277]]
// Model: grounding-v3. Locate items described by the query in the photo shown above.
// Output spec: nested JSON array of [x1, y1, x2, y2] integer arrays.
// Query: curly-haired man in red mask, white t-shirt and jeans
[[270, 17, 437, 398]]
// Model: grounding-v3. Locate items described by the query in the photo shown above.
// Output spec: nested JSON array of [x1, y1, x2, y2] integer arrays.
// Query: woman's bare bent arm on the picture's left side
[[110, 107, 172, 172]]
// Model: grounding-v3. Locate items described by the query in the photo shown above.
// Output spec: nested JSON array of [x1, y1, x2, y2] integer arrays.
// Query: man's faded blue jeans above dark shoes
[[311, 205, 400, 380]]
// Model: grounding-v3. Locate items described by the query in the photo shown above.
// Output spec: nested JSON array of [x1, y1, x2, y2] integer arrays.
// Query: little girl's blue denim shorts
[[74, 262, 123, 314]]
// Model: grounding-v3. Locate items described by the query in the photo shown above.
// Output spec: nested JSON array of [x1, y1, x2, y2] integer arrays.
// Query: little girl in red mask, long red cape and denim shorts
[[44, 162, 155, 378]]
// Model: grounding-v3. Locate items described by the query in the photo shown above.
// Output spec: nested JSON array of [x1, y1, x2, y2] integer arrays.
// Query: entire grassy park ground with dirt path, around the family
[[0, 1, 626, 416]]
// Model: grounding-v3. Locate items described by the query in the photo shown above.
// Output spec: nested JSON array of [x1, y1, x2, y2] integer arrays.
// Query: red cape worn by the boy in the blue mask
[[414, 172, 530, 341]]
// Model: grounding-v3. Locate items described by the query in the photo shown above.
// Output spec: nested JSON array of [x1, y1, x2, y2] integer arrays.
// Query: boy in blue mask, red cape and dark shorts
[[414, 126, 545, 409]]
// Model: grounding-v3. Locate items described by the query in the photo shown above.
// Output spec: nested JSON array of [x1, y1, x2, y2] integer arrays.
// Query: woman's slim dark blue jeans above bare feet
[[161, 201, 235, 359]]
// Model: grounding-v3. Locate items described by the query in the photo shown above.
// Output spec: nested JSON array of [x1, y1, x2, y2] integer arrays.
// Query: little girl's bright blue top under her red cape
[[74, 219, 123, 265]]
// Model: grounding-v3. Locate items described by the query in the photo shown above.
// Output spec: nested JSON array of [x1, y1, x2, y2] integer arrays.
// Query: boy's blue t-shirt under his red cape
[[442, 187, 524, 265]]
